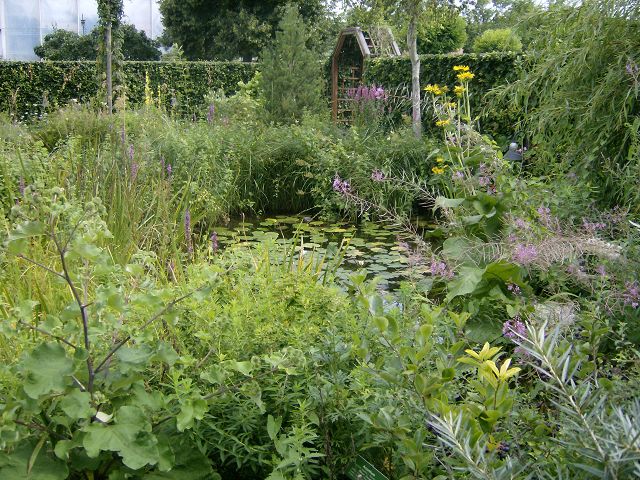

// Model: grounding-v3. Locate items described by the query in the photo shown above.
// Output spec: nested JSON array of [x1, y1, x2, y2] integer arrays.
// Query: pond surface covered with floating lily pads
[[213, 216, 430, 290]]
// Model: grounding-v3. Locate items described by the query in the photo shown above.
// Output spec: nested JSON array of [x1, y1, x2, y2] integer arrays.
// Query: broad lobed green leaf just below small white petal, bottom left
[[82, 406, 159, 470]]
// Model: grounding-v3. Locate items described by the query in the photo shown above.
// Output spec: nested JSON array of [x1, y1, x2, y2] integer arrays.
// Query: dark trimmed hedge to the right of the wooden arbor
[[365, 52, 524, 136]]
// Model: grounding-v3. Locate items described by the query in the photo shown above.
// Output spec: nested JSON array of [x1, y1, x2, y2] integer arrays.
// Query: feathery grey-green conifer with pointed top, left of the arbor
[[260, 5, 322, 123]]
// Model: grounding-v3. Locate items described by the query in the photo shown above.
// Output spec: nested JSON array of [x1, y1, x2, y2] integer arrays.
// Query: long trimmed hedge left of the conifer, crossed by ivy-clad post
[[0, 62, 256, 120]]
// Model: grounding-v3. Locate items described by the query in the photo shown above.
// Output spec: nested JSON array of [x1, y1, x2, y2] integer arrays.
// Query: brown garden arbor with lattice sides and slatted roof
[[331, 27, 400, 123]]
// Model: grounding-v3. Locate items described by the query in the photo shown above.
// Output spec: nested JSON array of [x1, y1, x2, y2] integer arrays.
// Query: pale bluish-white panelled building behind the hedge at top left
[[0, 0, 162, 60]]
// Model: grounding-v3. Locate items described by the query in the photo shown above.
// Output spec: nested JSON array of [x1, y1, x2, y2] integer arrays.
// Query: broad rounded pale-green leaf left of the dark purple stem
[[22, 343, 73, 399]]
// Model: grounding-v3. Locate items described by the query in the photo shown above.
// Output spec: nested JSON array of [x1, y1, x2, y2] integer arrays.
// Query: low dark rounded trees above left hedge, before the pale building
[[33, 24, 161, 61]]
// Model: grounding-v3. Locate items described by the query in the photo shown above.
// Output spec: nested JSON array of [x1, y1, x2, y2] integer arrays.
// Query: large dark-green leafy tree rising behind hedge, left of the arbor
[[160, 0, 327, 61]]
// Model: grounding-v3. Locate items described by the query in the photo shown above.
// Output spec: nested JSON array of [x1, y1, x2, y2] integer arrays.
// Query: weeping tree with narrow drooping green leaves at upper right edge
[[503, 0, 640, 211]]
